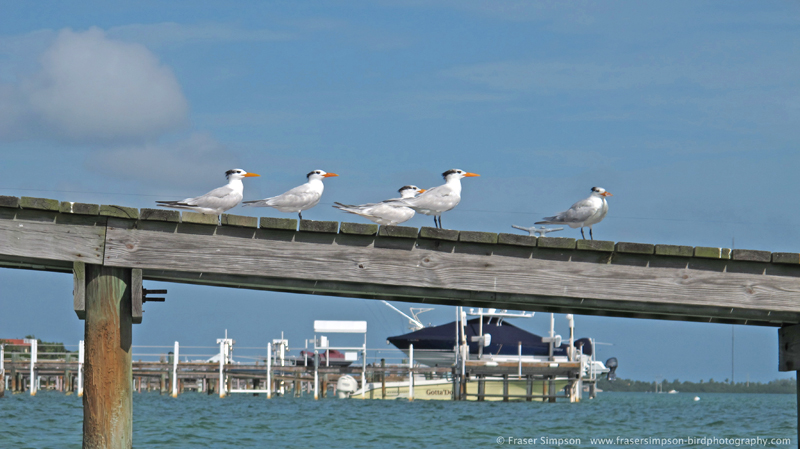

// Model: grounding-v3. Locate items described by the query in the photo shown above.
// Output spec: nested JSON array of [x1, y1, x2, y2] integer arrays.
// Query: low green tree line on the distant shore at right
[[597, 379, 797, 394]]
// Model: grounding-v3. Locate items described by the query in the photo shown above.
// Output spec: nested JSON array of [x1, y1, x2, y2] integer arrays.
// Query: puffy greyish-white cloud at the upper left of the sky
[[0, 28, 188, 142]]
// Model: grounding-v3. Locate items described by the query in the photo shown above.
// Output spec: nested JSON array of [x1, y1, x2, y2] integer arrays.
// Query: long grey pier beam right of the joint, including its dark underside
[[105, 219, 800, 325]]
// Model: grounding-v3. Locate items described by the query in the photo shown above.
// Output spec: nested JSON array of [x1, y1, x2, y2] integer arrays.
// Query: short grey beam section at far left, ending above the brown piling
[[0, 211, 105, 264]]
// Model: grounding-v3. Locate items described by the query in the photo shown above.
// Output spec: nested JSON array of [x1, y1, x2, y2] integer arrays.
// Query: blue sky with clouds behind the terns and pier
[[0, 0, 800, 382]]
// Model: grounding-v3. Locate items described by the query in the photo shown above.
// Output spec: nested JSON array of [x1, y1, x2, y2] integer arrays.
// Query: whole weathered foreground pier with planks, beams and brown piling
[[0, 196, 800, 447]]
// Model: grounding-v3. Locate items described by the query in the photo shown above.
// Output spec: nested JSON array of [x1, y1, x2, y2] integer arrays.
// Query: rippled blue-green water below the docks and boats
[[0, 391, 797, 448]]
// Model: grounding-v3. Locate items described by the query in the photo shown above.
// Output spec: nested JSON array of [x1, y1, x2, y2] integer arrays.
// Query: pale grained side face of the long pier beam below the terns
[[106, 228, 800, 316]]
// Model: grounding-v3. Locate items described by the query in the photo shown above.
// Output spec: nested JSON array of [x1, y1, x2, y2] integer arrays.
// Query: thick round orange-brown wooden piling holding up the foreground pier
[[83, 264, 133, 448]]
